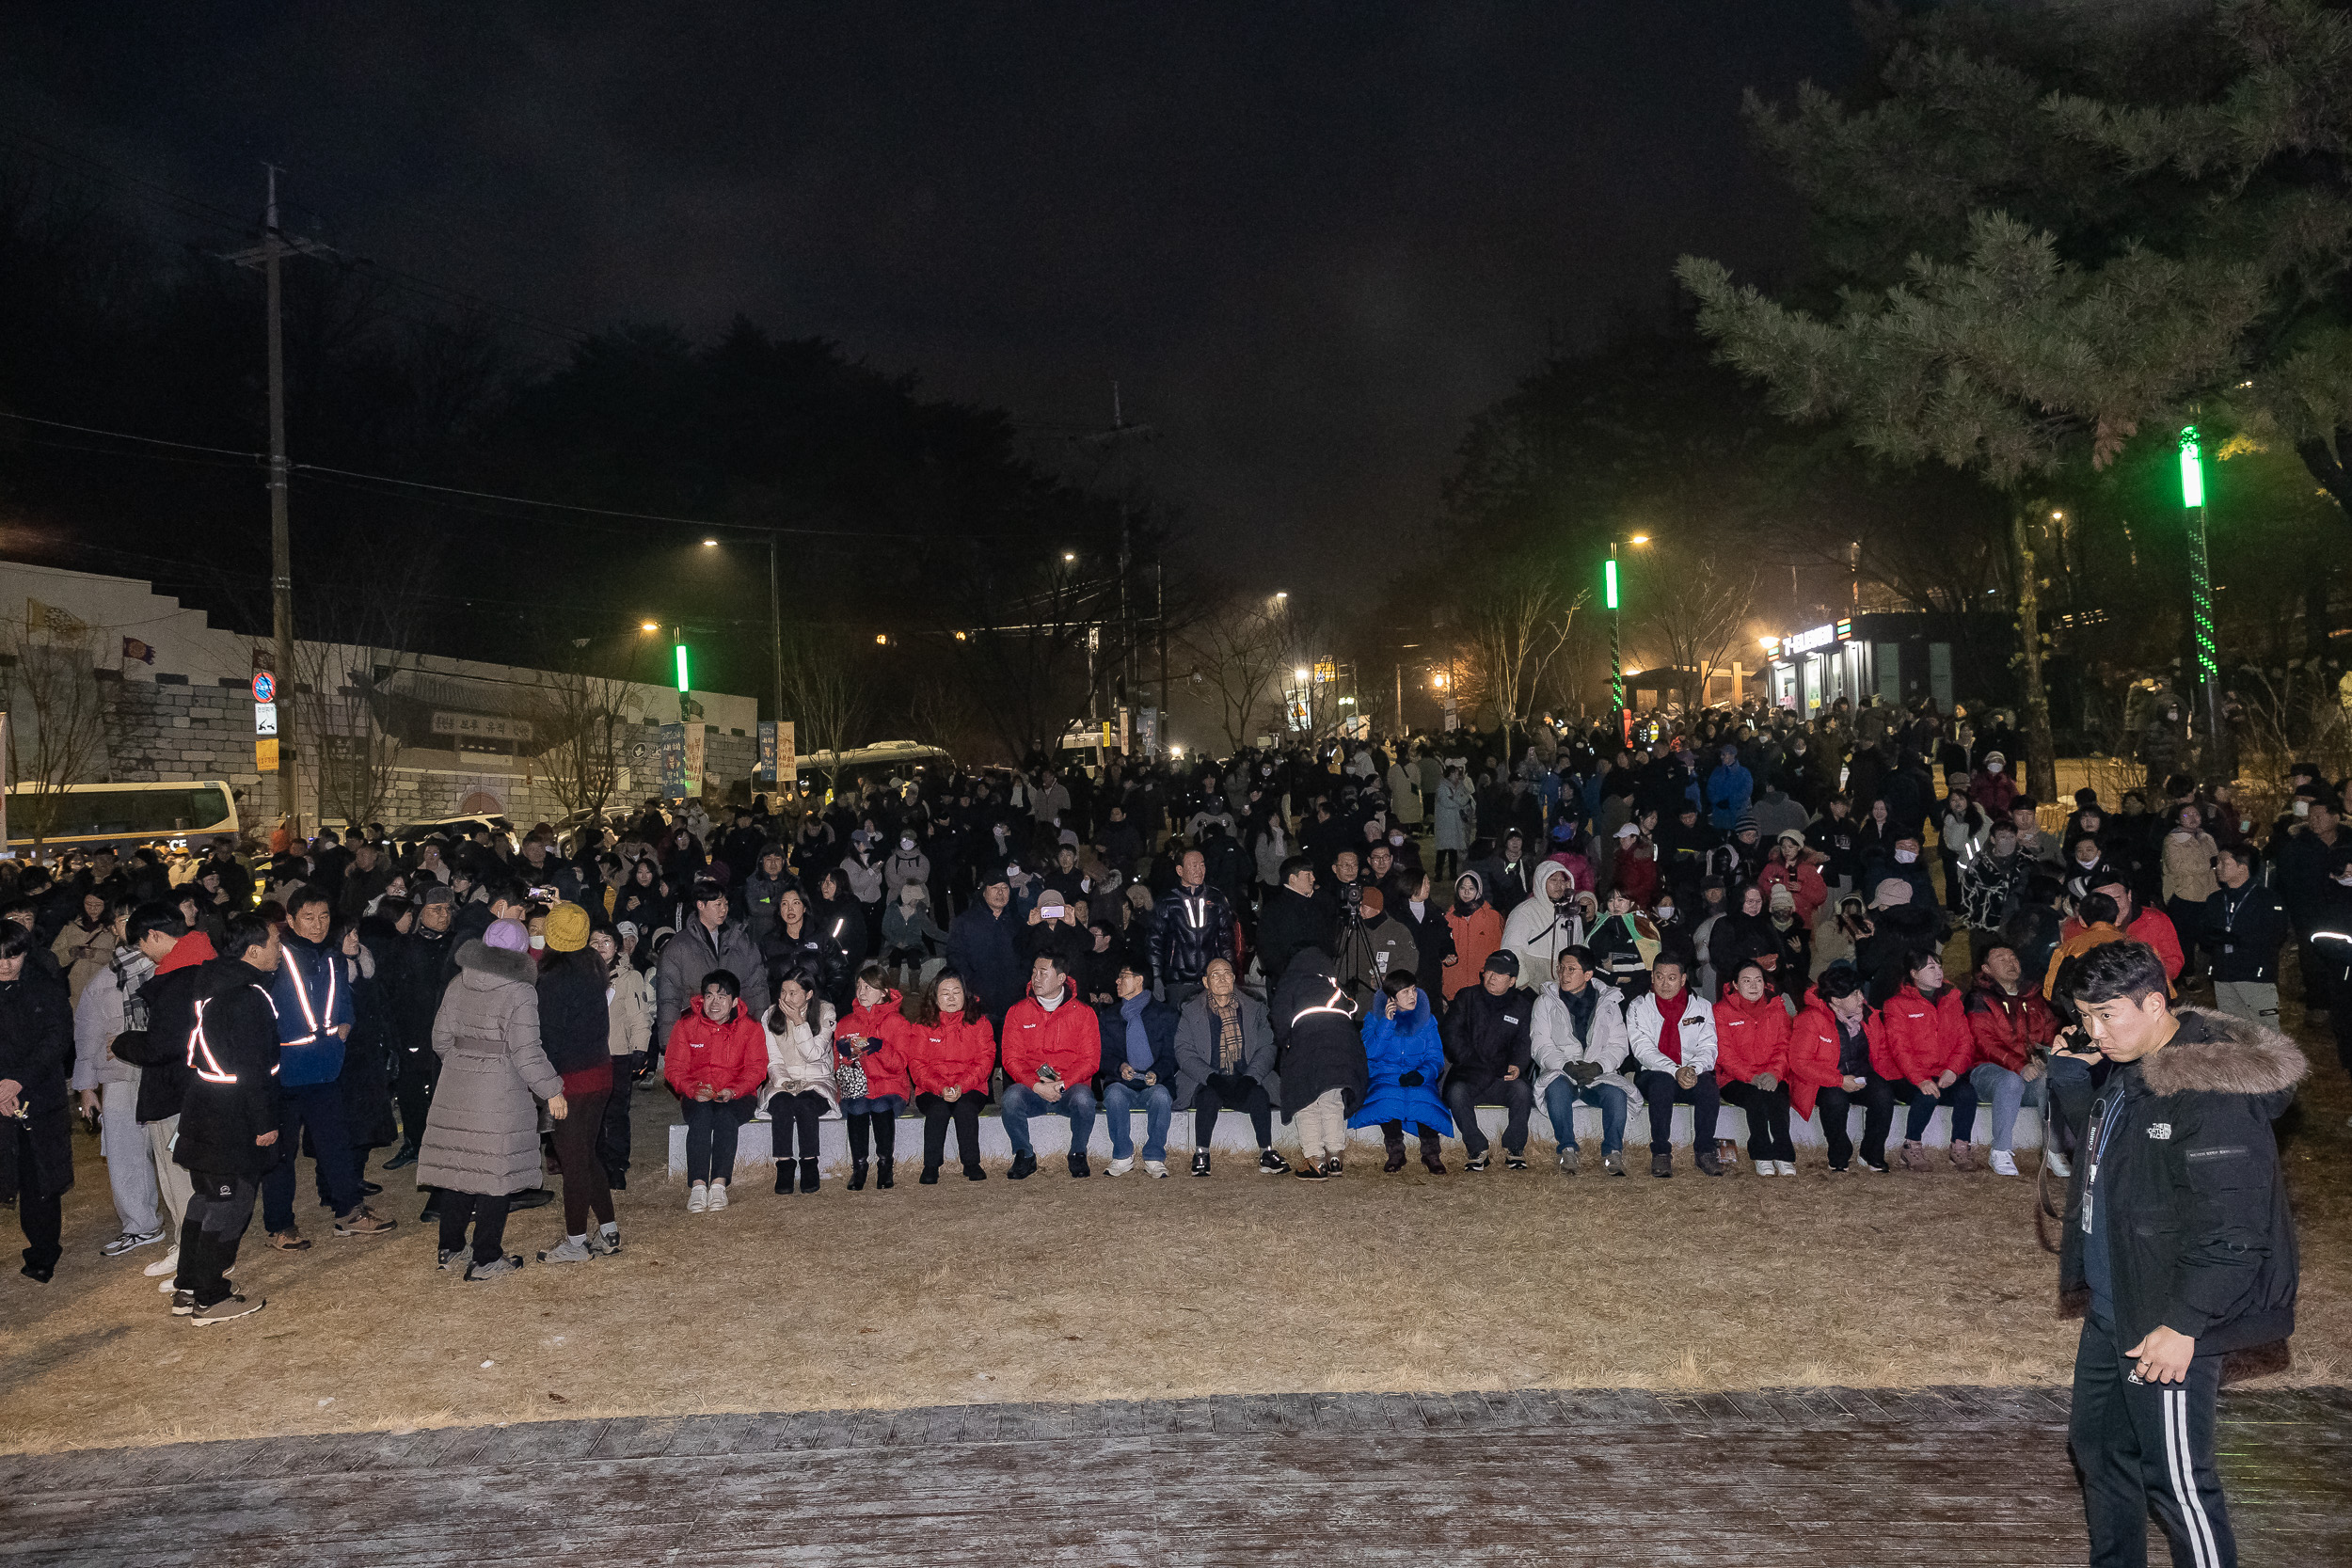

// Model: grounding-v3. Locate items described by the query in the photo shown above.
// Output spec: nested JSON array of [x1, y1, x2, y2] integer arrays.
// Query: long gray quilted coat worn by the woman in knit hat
[[417, 941, 564, 1195]]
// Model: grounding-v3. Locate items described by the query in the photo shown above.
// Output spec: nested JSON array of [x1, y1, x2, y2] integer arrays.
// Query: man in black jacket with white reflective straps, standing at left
[[172, 914, 280, 1323]]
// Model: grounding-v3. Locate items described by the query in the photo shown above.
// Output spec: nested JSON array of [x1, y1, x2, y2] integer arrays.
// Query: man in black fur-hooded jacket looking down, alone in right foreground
[[2058, 941, 2310, 1568]]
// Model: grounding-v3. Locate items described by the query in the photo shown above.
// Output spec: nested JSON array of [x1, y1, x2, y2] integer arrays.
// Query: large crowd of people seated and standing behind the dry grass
[[0, 686, 2324, 1323]]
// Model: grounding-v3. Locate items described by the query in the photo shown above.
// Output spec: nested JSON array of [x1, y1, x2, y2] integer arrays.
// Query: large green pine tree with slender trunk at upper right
[[1677, 0, 2352, 787]]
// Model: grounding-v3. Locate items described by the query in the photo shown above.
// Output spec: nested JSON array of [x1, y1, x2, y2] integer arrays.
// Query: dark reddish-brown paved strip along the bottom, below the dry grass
[[0, 1389, 2352, 1568]]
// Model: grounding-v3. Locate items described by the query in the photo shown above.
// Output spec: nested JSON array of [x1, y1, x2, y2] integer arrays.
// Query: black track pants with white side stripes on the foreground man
[[2068, 1317, 2237, 1568]]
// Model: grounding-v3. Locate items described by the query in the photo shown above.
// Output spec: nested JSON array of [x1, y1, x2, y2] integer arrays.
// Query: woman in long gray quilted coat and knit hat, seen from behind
[[417, 919, 569, 1279]]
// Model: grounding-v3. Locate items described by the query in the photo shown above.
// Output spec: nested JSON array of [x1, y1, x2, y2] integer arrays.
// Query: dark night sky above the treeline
[[0, 0, 1858, 574]]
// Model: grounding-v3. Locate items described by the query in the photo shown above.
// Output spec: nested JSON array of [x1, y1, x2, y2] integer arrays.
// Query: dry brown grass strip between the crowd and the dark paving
[[0, 991, 2352, 1450]]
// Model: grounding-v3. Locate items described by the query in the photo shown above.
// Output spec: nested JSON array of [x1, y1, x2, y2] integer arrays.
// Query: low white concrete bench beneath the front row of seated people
[[671, 1101, 2042, 1178]]
